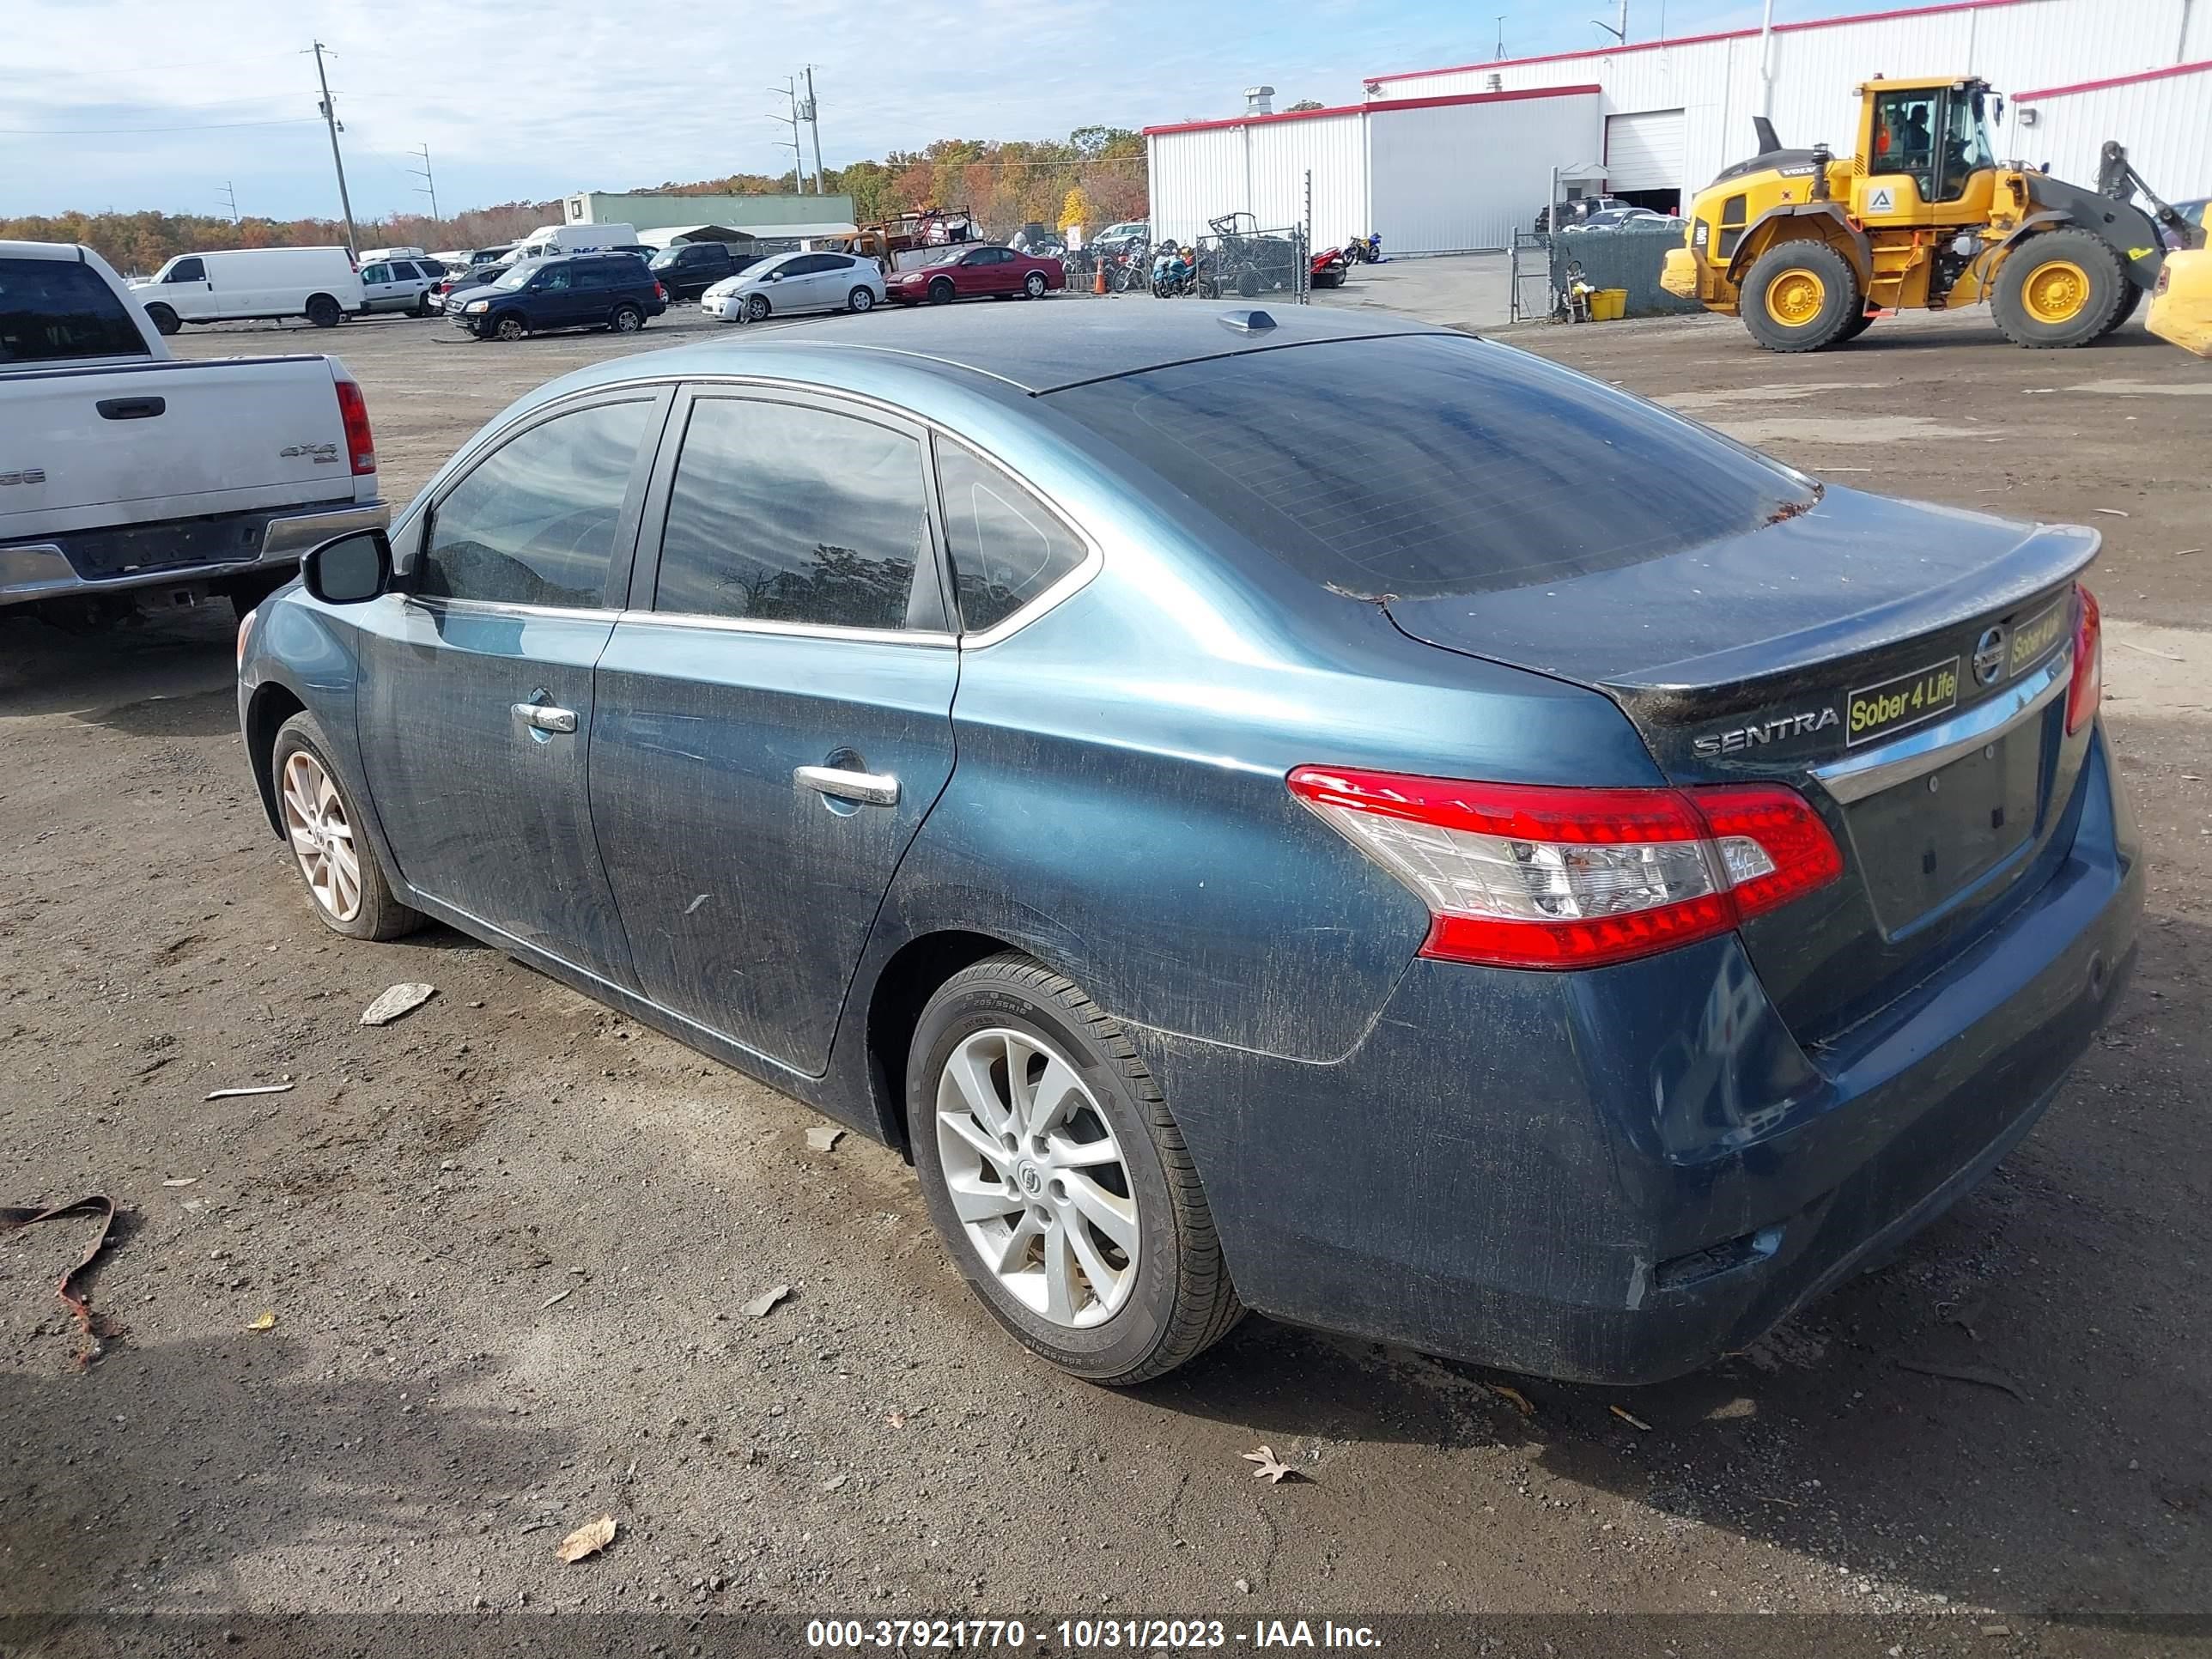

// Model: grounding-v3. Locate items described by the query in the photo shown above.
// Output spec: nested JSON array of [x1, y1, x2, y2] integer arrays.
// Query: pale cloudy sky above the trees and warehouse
[[0, 0, 1760, 219]]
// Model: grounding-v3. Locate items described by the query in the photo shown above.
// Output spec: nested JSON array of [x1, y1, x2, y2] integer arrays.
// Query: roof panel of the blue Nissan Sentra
[[548, 299, 1453, 396]]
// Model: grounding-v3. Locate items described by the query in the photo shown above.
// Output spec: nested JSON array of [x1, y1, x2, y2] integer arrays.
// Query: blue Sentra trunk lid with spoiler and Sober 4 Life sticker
[[1387, 489, 2097, 1042]]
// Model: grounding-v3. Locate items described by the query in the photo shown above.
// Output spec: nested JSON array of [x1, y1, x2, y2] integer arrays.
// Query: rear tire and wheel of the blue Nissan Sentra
[[907, 951, 1243, 1387]]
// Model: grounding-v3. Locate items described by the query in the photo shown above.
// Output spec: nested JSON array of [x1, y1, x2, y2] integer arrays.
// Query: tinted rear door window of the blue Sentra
[[653, 398, 929, 629]]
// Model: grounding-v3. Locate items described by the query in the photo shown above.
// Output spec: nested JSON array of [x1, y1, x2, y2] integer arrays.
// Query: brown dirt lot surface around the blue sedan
[[0, 299, 2212, 1656]]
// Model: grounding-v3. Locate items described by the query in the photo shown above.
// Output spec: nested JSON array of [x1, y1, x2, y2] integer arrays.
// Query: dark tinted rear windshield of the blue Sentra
[[1051, 334, 1818, 599]]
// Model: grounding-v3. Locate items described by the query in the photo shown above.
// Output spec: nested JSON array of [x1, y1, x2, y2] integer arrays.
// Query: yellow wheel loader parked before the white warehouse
[[1662, 80, 2201, 352]]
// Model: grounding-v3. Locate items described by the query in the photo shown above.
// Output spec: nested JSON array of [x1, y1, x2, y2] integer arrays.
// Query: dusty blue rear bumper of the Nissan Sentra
[[1137, 732, 2143, 1382]]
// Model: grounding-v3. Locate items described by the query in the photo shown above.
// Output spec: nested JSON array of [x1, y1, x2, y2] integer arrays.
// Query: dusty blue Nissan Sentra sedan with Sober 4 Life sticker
[[239, 303, 2143, 1382]]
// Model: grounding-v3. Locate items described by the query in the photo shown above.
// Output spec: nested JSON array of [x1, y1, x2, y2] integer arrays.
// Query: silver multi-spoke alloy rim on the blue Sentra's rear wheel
[[936, 1026, 1139, 1329]]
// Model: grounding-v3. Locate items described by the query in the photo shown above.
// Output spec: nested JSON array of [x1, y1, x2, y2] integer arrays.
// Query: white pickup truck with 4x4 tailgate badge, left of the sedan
[[0, 241, 389, 626]]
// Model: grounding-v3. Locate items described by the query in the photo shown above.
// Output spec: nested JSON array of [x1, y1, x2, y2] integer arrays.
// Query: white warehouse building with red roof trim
[[1146, 0, 2212, 252]]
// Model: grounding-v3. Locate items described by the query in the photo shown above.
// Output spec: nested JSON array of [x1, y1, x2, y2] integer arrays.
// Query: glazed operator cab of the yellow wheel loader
[[1851, 80, 2004, 230]]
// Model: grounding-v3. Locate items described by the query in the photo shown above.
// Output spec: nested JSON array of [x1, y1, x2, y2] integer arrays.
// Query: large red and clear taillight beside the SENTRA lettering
[[1290, 765, 1843, 969]]
